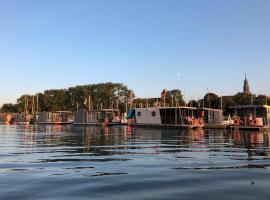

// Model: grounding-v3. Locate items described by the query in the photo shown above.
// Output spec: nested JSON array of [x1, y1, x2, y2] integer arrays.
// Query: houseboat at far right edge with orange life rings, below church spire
[[230, 105, 270, 131]]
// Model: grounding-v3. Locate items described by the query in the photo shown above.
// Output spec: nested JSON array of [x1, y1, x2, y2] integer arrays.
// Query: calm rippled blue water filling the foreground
[[0, 125, 270, 200]]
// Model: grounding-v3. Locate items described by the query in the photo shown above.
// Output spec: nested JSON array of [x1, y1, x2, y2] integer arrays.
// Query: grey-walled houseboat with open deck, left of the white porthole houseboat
[[74, 109, 121, 126]]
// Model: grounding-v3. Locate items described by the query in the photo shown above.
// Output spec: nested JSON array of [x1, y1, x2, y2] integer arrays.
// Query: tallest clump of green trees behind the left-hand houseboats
[[7, 82, 133, 112]]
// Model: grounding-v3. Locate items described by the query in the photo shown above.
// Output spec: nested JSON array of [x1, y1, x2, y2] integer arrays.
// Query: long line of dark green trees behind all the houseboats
[[0, 82, 270, 115]]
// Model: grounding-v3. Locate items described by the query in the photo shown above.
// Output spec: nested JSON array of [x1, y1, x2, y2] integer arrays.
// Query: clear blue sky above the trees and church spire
[[0, 0, 270, 105]]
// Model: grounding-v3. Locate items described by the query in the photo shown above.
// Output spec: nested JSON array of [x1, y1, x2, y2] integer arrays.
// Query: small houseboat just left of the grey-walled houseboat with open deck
[[38, 111, 73, 125]]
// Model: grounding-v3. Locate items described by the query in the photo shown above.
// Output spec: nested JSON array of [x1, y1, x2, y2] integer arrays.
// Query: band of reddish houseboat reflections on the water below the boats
[[16, 125, 270, 153]]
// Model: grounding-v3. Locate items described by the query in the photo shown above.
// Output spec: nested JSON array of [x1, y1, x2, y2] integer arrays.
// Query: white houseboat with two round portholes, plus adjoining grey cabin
[[128, 107, 223, 129]]
